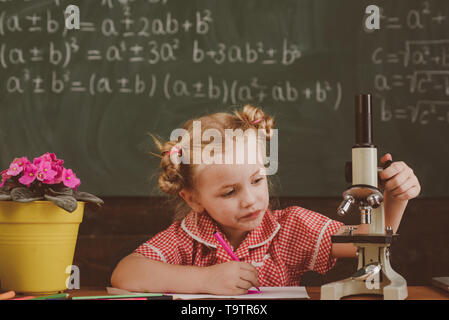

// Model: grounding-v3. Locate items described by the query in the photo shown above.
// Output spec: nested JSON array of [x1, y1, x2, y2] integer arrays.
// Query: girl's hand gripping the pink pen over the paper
[[200, 261, 259, 295]]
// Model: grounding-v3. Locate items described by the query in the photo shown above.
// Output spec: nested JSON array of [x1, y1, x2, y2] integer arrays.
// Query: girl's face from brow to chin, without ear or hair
[[196, 164, 269, 237]]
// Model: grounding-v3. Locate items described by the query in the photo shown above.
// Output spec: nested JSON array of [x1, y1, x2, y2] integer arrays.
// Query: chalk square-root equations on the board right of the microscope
[[368, 1, 449, 126]]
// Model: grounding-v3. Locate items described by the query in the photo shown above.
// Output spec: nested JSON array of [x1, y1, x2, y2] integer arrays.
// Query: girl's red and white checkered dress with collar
[[134, 206, 343, 286]]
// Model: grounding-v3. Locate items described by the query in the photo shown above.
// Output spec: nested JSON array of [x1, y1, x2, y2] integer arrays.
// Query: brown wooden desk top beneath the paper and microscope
[[67, 286, 449, 300]]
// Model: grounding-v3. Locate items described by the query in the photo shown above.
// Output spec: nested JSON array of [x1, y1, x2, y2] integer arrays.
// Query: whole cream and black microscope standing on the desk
[[321, 94, 407, 300]]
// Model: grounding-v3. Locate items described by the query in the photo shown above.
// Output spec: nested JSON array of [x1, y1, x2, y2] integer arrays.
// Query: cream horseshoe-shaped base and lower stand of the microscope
[[321, 243, 408, 300]]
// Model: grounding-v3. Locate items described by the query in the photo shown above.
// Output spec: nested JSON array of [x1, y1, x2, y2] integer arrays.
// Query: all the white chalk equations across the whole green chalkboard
[[0, 0, 449, 125]]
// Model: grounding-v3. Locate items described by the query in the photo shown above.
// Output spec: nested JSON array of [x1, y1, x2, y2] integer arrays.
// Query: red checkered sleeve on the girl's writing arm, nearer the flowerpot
[[134, 223, 193, 264]]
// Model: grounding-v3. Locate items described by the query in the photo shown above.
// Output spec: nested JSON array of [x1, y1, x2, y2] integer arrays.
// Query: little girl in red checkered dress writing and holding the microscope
[[111, 106, 421, 295]]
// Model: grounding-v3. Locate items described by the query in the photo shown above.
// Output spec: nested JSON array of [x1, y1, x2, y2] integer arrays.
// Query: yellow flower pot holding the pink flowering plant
[[0, 201, 85, 295]]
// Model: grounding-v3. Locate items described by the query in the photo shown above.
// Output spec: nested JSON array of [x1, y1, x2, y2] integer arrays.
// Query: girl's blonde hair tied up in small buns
[[151, 105, 275, 220]]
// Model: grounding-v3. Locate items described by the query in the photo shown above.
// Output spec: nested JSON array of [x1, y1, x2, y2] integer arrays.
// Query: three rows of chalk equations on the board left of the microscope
[[0, 0, 360, 114]]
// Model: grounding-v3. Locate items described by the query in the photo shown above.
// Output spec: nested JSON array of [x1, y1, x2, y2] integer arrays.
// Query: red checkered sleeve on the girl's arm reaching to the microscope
[[281, 207, 343, 274]]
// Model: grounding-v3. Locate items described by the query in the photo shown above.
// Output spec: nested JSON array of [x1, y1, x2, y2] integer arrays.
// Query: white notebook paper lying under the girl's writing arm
[[106, 287, 309, 300]]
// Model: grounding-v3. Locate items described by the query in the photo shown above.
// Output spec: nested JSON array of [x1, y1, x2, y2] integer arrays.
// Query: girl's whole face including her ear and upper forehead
[[180, 131, 269, 245]]
